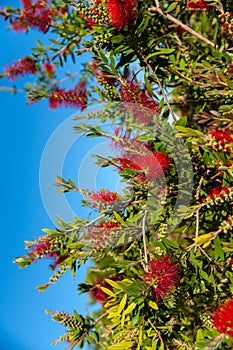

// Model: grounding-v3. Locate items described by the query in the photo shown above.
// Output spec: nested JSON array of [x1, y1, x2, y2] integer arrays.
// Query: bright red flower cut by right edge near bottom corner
[[212, 298, 233, 337]]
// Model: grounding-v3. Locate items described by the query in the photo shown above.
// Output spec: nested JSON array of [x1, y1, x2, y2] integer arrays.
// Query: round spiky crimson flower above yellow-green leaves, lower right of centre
[[143, 255, 179, 300]]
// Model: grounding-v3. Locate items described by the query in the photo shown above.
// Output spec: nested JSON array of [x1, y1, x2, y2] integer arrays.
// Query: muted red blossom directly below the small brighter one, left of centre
[[87, 221, 122, 249]]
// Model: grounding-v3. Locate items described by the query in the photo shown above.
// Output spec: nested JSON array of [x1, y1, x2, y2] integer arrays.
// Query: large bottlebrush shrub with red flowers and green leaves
[[0, 0, 233, 350]]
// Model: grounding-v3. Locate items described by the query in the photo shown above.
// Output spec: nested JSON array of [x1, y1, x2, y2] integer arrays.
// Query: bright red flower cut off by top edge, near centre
[[106, 0, 137, 30]]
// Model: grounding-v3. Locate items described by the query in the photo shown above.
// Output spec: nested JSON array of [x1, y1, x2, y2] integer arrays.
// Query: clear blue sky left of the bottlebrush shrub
[[0, 0, 120, 350]]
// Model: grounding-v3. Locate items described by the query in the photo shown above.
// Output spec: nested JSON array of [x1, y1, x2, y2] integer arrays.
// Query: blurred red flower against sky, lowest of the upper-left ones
[[48, 86, 87, 110]]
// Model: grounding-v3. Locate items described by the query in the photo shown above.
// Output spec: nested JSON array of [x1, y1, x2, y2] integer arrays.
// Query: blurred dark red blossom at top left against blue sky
[[12, 0, 54, 33]]
